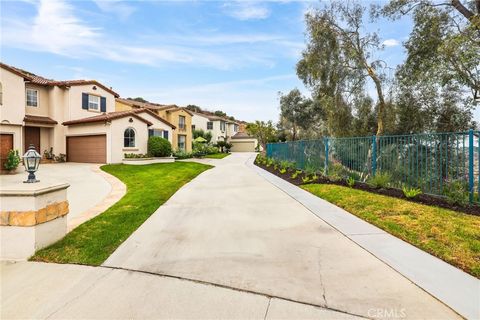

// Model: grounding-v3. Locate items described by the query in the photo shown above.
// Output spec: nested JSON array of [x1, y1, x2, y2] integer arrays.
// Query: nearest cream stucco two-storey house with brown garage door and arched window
[[0, 63, 175, 167]]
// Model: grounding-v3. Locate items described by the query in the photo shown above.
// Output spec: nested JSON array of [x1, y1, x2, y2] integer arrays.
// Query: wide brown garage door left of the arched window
[[67, 135, 107, 163]]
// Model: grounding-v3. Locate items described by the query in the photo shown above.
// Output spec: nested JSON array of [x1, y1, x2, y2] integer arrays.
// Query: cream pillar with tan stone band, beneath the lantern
[[0, 180, 69, 260]]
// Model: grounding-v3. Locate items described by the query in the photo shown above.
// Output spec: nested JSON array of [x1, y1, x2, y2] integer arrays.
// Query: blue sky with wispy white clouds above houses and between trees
[[1, 0, 462, 121]]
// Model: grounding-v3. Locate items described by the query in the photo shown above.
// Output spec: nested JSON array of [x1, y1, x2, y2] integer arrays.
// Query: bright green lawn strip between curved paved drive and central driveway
[[31, 162, 211, 265]]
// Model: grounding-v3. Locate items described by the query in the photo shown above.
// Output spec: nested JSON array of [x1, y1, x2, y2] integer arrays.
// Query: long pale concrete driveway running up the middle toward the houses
[[104, 153, 458, 319]]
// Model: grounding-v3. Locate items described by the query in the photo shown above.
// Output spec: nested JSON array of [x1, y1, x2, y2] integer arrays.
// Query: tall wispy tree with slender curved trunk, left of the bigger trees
[[297, 1, 392, 135]]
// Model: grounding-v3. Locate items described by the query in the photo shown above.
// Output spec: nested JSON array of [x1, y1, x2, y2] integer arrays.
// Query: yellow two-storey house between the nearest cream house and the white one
[[115, 98, 193, 152]]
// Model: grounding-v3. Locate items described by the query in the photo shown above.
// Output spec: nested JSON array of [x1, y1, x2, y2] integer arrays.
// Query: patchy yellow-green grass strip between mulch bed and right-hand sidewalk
[[302, 184, 480, 278]]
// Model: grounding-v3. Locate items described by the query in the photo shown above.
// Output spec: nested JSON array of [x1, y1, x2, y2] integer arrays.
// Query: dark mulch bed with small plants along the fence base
[[255, 161, 480, 216]]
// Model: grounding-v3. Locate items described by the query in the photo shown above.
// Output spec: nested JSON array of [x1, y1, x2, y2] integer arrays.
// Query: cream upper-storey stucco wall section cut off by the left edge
[[0, 68, 25, 125]]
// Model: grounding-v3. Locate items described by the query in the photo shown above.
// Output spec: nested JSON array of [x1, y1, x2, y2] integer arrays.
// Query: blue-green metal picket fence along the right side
[[267, 130, 480, 202]]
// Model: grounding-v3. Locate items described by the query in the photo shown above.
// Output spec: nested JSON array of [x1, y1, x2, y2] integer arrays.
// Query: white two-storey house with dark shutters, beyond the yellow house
[[192, 112, 238, 143]]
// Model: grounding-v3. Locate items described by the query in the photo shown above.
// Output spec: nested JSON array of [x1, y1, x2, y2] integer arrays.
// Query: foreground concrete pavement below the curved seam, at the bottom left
[[0, 262, 359, 320]]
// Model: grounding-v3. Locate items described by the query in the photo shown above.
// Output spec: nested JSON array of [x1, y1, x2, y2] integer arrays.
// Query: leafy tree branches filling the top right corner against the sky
[[377, 0, 480, 100]]
